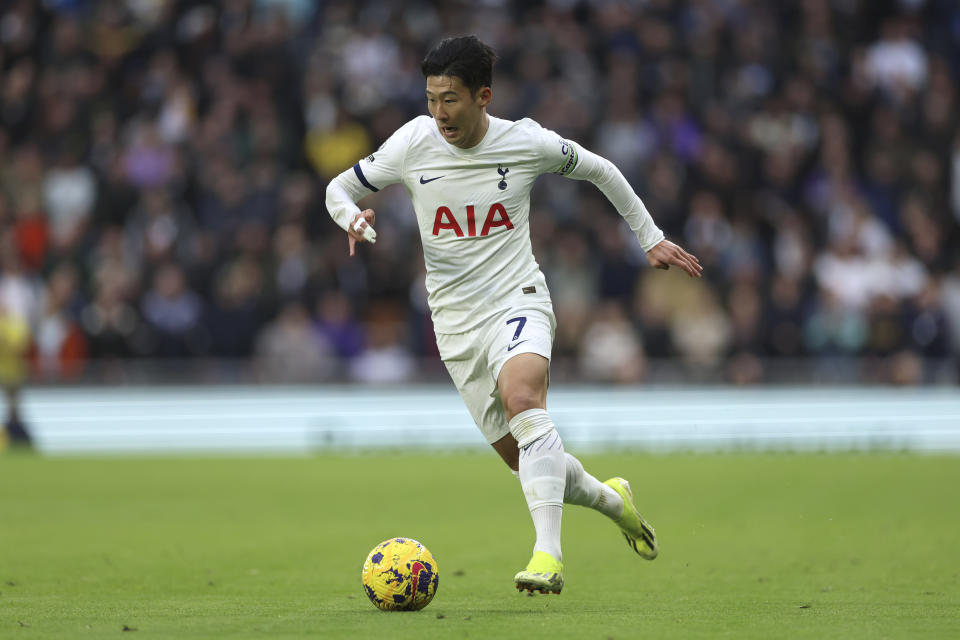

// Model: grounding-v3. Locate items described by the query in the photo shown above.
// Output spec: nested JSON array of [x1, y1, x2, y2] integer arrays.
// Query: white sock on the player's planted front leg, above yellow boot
[[510, 409, 566, 560]]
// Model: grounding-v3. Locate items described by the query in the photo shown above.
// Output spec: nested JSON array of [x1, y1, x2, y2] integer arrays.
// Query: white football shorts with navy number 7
[[437, 303, 557, 444]]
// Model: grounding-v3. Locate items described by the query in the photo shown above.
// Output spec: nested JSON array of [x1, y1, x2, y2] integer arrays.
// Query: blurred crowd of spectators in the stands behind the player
[[0, 0, 960, 384]]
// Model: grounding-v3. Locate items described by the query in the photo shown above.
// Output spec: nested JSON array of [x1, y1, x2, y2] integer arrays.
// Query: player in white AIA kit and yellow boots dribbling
[[326, 36, 701, 593]]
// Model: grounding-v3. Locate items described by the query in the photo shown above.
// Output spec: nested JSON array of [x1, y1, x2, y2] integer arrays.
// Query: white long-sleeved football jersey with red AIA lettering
[[327, 116, 663, 333]]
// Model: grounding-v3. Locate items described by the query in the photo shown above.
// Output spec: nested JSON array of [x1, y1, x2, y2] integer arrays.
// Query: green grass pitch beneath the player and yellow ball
[[0, 452, 960, 640]]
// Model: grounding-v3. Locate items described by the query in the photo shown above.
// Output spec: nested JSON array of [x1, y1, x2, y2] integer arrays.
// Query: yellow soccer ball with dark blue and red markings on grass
[[361, 538, 440, 611]]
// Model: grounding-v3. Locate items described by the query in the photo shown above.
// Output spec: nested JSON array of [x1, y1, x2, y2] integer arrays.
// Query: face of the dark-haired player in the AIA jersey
[[427, 76, 493, 149]]
